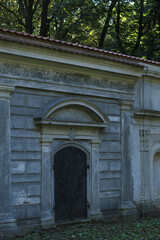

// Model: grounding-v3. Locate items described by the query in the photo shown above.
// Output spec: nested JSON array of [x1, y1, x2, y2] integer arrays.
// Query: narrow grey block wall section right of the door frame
[[100, 100, 121, 211]]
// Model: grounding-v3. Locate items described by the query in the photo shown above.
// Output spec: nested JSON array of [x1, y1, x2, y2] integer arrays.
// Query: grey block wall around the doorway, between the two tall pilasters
[[11, 88, 121, 224]]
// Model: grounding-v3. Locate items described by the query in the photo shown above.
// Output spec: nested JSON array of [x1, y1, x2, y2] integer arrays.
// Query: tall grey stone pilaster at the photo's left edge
[[0, 84, 17, 235]]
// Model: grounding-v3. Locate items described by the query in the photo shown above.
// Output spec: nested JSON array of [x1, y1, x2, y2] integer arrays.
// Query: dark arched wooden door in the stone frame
[[54, 147, 87, 222]]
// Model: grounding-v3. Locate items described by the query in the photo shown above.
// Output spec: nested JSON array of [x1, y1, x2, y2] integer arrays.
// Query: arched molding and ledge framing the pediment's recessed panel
[[35, 99, 110, 128]]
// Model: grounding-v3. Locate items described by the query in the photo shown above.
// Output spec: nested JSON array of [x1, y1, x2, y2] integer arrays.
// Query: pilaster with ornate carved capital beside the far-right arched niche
[[139, 127, 153, 215]]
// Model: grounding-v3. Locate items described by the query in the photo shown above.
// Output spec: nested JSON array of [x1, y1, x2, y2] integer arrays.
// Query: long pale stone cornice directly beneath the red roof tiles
[[0, 42, 143, 77]]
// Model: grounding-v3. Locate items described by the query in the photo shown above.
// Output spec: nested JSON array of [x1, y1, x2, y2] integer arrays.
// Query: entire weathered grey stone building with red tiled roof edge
[[0, 29, 160, 234]]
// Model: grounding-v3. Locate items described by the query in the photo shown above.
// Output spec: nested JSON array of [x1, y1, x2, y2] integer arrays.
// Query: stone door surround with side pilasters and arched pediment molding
[[35, 99, 109, 228]]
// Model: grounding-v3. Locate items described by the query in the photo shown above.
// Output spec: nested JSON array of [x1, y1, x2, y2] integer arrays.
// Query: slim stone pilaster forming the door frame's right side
[[91, 140, 102, 218]]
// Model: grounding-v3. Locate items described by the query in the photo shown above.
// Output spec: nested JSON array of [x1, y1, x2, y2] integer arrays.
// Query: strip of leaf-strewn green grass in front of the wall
[[10, 218, 160, 240]]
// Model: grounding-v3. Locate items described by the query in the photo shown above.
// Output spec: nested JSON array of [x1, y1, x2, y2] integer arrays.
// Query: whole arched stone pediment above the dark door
[[35, 99, 109, 127]]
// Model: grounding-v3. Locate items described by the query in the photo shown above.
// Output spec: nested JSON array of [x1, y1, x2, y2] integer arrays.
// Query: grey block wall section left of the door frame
[[11, 89, 42, 224]]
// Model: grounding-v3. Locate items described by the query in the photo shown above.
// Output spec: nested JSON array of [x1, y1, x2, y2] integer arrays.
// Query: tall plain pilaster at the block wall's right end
[[120, 101, 137, 218]]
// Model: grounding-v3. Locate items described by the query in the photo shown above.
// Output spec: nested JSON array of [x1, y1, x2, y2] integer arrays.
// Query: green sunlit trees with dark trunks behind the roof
[[0, 0, 160, 61]]
